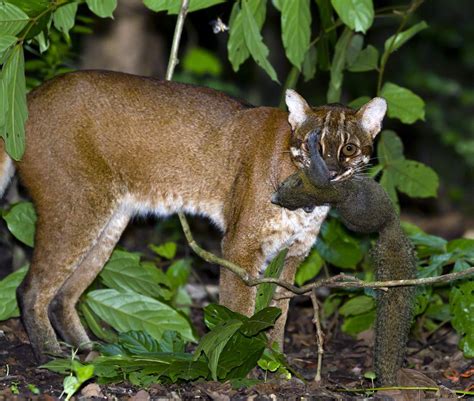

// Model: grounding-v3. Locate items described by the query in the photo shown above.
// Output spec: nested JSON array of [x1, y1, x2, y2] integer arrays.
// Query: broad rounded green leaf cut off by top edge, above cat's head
[[331, 0, 374, 33]]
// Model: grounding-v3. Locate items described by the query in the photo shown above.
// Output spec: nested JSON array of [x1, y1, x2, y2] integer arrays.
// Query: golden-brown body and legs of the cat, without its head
[[0, 71, 327, 360]]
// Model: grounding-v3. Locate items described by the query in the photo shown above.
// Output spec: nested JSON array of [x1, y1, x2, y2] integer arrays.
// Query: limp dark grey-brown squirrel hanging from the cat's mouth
[[272, 131, 416, 386]]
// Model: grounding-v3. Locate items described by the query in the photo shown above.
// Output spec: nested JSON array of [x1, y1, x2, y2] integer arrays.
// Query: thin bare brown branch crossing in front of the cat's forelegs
[[178, 213, 474, 295]]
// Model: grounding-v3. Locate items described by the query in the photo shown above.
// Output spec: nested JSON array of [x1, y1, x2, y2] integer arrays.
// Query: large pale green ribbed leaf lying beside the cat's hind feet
[[86, 289, 195, 341]]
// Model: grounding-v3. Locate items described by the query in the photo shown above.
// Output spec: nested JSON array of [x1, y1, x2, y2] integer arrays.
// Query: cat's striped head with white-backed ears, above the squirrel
[[286, 89, 387, 181]]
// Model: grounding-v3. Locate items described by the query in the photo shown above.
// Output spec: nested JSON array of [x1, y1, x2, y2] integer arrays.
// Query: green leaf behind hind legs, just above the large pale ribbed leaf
[[99, 250, 167, 298]]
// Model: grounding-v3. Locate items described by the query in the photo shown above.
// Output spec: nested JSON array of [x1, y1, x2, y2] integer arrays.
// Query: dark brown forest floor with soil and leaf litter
[[0, 300, 474, 401]]
